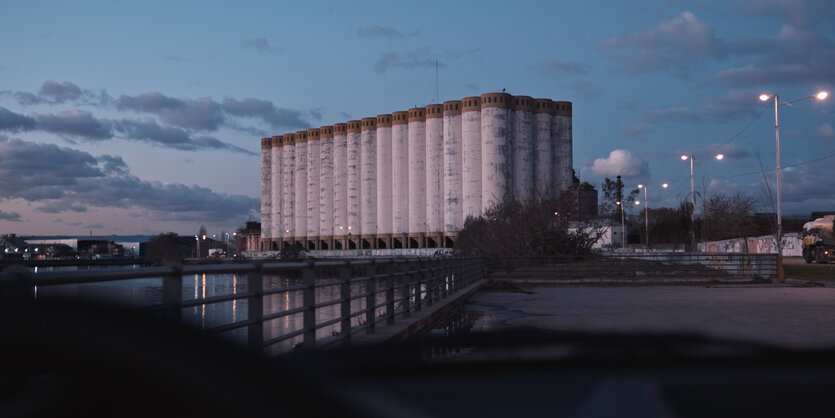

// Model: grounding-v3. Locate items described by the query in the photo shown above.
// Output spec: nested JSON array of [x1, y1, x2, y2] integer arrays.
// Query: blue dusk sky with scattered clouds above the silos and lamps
[[0, 0, 835, 235]]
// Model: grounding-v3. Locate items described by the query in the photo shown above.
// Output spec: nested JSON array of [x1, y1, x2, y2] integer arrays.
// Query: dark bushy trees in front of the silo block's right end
[[455, 199, 602, 257]]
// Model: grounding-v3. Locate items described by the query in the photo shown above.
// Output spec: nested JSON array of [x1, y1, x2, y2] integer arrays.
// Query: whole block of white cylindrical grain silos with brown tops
[[261, 93, 574, 251]]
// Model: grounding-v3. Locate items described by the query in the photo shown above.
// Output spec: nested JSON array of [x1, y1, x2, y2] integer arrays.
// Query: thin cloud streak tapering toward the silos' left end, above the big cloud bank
[[114, 119, 254, 155]]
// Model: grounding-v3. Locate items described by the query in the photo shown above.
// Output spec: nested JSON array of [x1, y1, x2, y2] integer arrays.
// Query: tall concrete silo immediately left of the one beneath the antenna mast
[[409, 108, 426, 248]]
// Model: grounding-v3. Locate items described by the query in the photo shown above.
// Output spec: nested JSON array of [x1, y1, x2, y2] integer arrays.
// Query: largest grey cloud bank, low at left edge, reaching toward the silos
[[0, 139, 259, 222]]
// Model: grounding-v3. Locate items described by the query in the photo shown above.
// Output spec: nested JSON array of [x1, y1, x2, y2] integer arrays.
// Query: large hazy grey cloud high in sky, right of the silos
[[598, 11, 726, 78]]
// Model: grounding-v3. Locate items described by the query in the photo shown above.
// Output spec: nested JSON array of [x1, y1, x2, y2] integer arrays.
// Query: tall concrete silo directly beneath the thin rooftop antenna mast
[[425, 104, 444, 248]]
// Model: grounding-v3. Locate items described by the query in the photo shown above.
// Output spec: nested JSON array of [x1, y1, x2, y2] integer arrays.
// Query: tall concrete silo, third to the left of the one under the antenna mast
[[376, 115, 394, 248]]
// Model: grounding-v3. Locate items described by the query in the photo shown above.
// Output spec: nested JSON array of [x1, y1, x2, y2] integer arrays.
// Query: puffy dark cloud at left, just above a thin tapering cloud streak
[[116, 92, 223, 131]]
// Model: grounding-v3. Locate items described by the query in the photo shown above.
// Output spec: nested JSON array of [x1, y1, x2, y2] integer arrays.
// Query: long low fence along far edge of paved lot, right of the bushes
[[485, 253, 778, 282]]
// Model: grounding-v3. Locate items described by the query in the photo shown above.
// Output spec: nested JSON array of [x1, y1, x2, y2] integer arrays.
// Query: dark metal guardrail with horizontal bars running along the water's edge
[[0, 258, 484, 354]]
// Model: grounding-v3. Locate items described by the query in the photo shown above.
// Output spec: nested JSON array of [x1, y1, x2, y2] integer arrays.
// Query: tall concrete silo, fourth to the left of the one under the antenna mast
[[364, 117, 377, 249]]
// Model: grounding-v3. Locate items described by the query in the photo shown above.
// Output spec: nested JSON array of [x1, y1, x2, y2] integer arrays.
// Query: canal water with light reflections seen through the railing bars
[[30, 265, 385, 354]]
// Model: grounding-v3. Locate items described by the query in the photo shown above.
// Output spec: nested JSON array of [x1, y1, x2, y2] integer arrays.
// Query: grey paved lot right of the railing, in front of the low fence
[[468, 285, 835, 347]]
